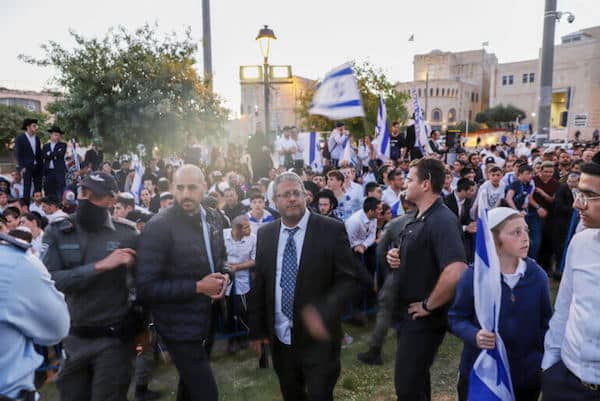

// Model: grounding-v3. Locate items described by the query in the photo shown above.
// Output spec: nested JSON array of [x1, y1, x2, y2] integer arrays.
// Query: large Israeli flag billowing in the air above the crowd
[[308, 63, 365, 120]]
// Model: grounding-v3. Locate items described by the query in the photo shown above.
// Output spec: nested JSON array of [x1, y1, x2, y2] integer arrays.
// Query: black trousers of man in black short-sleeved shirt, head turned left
[[394, 322, 446, 401]]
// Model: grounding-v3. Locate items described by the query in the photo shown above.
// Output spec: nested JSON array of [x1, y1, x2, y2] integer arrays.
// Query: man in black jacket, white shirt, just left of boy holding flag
[[444, 178, 477, 263]]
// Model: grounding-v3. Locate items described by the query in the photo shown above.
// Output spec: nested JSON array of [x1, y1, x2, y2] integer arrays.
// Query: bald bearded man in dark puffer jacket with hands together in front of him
[[137, 165, 231, 401]]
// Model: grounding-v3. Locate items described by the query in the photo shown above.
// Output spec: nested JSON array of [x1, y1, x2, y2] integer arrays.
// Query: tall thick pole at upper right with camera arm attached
[[536, 0, 557, 147]]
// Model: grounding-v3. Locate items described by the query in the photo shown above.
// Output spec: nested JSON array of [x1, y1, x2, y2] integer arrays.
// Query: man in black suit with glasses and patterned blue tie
[[249, 173, 368, 401]]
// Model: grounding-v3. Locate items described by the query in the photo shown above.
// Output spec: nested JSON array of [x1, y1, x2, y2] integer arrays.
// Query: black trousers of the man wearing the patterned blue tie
[[271, 339, 340, 401]]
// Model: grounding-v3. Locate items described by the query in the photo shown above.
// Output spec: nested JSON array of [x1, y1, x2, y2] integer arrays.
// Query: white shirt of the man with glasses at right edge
[[542, 228, 600, 384]]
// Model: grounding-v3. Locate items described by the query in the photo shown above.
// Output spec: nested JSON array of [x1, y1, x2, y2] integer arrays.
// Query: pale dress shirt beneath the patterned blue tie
[[275, 210, 310, 345]]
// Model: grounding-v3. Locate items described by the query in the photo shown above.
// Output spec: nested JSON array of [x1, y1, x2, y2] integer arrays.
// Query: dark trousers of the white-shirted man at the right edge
[[542, 361, 600, 401]]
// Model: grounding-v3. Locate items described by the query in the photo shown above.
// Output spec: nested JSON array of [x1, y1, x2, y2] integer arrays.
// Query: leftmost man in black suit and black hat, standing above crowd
[[15, 118, 42, 203]]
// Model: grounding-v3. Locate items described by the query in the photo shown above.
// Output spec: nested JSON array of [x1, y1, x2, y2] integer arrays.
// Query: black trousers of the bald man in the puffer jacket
[[166, 341, 219, 401]]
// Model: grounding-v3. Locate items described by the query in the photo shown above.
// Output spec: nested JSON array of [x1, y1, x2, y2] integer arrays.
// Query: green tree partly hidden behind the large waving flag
[[296, 62, 408, 139]]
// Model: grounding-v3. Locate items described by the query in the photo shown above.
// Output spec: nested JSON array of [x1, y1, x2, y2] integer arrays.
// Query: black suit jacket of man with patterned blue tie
[[248, 211, 368, 348]]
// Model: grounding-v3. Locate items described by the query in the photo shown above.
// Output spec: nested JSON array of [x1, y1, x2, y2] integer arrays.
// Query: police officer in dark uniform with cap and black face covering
[[42, 171, 137, 401]]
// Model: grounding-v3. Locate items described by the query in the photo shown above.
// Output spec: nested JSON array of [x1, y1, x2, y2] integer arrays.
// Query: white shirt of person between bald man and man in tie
[[223, 228, 256, 296]]
